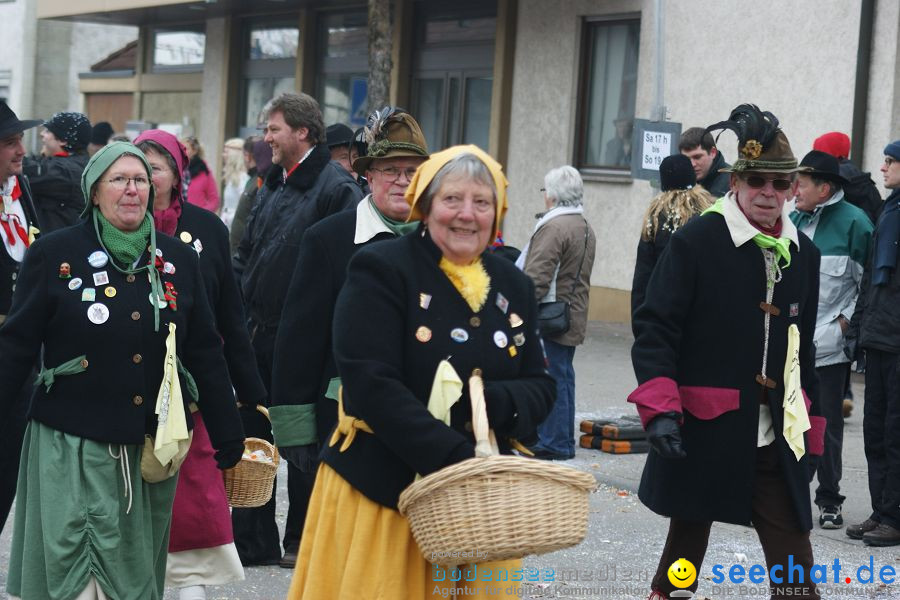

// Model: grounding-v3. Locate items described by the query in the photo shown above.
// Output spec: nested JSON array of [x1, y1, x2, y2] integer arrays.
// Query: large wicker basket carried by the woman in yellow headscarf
[[398, 372, 597, 565]]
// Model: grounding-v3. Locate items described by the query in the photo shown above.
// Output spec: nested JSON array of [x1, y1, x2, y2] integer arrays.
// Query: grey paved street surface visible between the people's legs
[[0, 323, 900, 600]]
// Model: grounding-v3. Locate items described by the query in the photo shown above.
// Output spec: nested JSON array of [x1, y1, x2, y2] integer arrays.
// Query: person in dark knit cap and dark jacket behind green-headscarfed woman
[[24, 112, 91, 233]]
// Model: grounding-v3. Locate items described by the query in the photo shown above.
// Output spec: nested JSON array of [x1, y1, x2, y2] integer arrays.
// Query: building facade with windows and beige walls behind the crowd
[[31, 0, 900, 321]]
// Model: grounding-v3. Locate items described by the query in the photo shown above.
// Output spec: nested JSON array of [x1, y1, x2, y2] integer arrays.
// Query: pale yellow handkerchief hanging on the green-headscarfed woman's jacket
[[153, 323, 190, 466]]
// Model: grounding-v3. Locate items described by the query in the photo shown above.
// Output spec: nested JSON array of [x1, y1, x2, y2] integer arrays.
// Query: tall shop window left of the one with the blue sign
[[239, 18, 300, 137]]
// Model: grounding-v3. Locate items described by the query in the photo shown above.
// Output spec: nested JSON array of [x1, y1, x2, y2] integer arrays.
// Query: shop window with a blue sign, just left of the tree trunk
[[316, 11, 369, 129]]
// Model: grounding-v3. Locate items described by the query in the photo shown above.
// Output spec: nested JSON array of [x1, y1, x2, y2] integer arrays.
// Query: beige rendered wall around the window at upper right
[[504, 0, 900, 319]]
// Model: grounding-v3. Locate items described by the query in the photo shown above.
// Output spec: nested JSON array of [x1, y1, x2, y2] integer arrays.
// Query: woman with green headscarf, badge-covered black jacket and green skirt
[[0, 142, 244, 600]]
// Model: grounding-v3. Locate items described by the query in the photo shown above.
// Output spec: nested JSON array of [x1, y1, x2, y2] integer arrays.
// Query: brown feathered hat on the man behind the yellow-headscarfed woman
[[353, 106, 428, 173]]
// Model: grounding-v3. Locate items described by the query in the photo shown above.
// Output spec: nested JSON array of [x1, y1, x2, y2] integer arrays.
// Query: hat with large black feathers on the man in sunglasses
[[706, 104, 797, 173]]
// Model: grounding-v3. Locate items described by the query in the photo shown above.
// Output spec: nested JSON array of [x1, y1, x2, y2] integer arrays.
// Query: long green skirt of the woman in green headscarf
[[7, 420, 178, 600]]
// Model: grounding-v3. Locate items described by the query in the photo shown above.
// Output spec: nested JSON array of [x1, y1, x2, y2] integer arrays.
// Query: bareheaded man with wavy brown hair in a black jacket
[[232, 93, 362, 567]]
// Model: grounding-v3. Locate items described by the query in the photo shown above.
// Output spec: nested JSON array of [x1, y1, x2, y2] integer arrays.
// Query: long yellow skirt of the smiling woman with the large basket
[[288, 463, 522, 600]]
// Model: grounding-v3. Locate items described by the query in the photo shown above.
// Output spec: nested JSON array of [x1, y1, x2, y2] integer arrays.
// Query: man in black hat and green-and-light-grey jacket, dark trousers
[[791, 150, 872, 529]]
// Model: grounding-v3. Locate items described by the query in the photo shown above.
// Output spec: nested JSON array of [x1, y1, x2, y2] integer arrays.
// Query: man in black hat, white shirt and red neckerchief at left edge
[[0, 101, 40, 531]]
